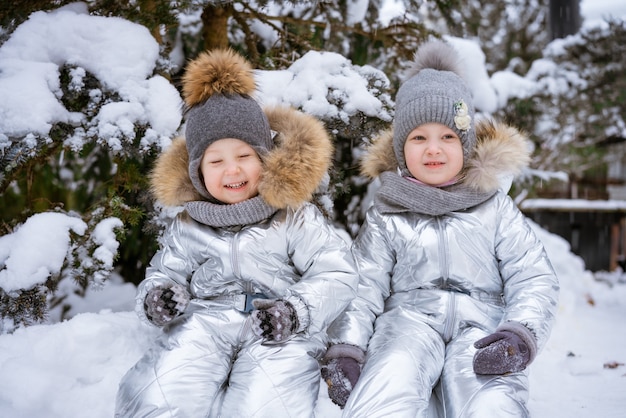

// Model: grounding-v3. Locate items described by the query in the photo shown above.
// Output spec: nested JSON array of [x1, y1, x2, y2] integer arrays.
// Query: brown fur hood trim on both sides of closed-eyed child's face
[[150, 107, 333, 209]]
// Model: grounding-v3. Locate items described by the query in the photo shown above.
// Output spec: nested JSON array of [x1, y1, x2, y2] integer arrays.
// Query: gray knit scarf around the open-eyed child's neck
[[374, 171, 496, 216]]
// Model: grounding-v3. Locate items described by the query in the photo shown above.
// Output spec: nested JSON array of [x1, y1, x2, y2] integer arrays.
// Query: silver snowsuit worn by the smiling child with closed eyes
[[116, 105, 358, 418]]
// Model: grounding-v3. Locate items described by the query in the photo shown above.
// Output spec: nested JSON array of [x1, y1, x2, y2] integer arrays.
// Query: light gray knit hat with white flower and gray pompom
[[393, 41, 476, 173]]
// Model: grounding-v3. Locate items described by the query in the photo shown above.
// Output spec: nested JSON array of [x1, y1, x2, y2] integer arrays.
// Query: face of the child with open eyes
[[404, 123, 463, 186]]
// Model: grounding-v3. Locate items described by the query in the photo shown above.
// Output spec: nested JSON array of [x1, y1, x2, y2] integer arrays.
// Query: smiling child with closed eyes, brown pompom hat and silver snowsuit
[[115, 50, 358, 418]]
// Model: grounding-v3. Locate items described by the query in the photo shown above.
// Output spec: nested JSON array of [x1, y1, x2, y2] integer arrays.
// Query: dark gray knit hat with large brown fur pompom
[[183, 50, 274, 200]]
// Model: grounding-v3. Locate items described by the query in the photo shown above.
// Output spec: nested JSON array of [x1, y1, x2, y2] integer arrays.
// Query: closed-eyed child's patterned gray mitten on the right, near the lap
[[250, 299, 299, 342]]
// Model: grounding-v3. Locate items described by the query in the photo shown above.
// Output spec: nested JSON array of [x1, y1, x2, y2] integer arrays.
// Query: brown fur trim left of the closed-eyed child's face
[[150, 138, 202, 206]]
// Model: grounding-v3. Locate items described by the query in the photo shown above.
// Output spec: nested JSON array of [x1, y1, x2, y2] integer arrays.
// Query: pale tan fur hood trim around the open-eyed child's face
[[361, 120, 531, 192]]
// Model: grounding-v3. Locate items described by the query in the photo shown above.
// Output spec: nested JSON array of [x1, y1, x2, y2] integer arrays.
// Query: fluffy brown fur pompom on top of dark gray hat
[[183, 49, 256, 107]]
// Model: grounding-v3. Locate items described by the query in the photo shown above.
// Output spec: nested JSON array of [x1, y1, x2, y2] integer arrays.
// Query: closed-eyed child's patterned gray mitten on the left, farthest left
[[143, 283, 189, 327]]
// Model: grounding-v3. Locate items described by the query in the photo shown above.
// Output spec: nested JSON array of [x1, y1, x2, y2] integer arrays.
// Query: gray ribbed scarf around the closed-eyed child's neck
[[185, 196, 278, 227]]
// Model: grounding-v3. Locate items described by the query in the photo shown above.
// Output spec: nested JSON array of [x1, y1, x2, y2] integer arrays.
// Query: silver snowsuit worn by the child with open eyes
[[329, 120, 559, 418]]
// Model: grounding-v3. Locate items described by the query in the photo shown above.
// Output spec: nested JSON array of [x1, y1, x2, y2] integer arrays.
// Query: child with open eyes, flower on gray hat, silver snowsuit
[[322, 41, 559, 418]]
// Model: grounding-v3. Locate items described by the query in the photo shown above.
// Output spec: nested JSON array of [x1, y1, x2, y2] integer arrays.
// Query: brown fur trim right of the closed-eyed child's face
[[259, 107, 333, 208]]
